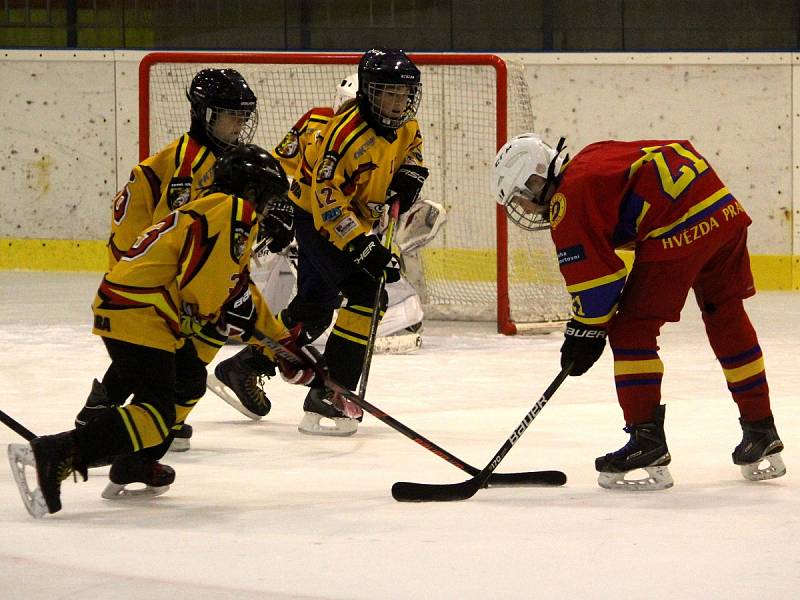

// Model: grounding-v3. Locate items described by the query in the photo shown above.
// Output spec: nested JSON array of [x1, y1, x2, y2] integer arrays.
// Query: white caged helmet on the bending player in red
[[492, 133, 569, 231]]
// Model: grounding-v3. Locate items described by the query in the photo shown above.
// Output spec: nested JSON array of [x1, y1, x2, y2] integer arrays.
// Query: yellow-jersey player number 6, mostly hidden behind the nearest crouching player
[[75, 69, 268, 451]]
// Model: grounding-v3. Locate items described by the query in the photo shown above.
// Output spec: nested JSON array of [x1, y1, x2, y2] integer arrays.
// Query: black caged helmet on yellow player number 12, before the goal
[[358, 48, 422, 129]]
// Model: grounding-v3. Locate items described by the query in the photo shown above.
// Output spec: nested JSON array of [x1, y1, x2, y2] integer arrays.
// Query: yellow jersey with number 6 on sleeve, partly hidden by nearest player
[[108, 133, 216, 270]]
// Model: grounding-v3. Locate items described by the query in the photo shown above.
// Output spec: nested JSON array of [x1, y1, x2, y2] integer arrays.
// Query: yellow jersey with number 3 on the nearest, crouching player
[[92, 192, 288, 355]]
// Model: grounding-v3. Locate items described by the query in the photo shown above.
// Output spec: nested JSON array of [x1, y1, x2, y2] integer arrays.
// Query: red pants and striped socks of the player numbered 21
[[608, 228, 772, 425]]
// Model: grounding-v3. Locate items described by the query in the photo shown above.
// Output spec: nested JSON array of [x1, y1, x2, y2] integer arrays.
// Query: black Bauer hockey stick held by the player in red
[[392, 364, 572, 502]]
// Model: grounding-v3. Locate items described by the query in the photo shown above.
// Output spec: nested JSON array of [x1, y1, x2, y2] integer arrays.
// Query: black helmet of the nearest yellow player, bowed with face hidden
[[211, 144, 289, 218]]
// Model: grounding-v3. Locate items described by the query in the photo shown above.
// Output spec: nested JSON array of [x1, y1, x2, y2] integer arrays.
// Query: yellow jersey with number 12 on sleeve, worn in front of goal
[[298, 105, 423, 249]]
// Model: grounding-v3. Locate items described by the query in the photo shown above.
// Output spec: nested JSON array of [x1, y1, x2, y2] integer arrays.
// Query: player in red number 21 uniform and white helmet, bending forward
[[493, 134, 786, 490]]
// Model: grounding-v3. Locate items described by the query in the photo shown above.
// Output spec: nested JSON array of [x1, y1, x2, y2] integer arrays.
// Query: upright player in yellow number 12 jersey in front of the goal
[[290, 49, 428, 435]]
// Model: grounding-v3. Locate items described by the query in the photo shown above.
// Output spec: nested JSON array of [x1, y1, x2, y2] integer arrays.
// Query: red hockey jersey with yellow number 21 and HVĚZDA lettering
[[550, 140, 750, 325]]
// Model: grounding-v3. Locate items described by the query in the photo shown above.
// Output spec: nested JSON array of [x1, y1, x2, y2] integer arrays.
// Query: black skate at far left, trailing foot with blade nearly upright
[[8, 431, 88, 519]]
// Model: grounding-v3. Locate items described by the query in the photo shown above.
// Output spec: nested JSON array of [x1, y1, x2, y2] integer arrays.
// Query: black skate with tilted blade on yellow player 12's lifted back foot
[[207, 346, 275, 421]]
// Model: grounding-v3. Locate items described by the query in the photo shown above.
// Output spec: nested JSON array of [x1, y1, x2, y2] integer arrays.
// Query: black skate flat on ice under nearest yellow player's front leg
[[101, 454, 175, 500]]
